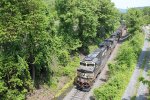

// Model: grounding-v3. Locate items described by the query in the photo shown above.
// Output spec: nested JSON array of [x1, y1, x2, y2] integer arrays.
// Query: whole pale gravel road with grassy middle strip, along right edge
[[122, 27, 150, 100]]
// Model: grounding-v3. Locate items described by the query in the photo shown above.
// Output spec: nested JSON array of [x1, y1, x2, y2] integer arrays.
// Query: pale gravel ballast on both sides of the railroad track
[[63, 32, 127, 100]]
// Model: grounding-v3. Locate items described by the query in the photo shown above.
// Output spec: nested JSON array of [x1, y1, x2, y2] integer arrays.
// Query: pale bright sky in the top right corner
[[111, 0, 150, 9]]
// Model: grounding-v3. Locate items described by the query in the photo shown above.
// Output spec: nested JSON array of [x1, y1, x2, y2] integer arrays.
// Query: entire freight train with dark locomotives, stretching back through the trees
[[74, 24, 126, 91]]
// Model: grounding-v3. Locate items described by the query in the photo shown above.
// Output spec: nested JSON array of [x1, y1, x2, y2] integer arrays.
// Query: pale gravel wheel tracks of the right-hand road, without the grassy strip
[[122, 28, 150, 100]]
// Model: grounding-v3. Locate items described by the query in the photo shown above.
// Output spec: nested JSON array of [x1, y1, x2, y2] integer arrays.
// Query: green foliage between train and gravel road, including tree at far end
[[94, 9, 144, 100]]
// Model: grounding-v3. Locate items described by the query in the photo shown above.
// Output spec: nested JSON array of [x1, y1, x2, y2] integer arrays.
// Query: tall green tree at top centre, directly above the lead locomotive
[[56, 0, 97, 54]]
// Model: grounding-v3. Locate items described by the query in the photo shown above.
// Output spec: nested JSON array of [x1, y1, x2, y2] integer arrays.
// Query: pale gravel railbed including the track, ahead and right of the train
[[60, 32, 128, 100]]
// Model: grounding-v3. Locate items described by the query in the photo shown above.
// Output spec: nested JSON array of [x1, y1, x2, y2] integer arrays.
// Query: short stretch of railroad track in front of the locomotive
[[70, 89, 88, 100]]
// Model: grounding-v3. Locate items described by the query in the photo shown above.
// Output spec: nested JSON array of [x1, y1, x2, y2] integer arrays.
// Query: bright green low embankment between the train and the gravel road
[[94, 31, 144, 100]]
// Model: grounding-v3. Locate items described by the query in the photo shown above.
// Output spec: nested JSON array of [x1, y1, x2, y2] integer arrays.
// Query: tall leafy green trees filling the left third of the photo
[[0, 0, 52, 100]]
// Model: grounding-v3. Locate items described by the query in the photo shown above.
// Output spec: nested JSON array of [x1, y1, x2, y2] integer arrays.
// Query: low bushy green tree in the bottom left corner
[[0, 55, 33, 100]]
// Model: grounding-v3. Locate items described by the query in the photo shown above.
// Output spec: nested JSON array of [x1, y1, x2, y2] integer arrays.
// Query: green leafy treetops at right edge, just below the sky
[[123, 7, 150, 33]]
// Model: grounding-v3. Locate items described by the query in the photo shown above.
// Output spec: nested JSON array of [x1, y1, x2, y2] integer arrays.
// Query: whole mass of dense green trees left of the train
[[0, 0, 119, 100]]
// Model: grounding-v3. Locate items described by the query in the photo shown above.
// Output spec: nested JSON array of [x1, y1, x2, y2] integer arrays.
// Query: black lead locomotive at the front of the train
[[74, 44, 110, 91]]
